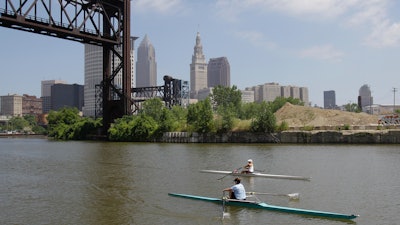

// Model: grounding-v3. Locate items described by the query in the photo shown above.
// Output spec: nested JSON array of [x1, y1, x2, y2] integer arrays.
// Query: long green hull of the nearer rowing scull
[[168, 193, 358, 220]]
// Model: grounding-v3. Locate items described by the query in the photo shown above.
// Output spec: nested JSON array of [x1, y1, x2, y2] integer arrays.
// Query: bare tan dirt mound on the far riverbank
[[275, 103, 378, 127]]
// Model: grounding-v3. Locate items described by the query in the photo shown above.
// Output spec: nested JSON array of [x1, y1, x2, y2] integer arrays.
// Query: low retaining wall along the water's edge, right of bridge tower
[[158, 129, 400, 144]]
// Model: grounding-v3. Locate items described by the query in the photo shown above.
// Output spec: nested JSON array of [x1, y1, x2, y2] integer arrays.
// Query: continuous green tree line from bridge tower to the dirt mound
[[109, 86, 304, 141]]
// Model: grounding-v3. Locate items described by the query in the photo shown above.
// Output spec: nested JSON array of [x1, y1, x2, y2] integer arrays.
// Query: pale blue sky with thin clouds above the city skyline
[[0, 0, 400, 106]]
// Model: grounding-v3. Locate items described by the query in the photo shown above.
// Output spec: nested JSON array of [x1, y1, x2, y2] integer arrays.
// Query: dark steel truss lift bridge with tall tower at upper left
[[0, 0, 188, 134]]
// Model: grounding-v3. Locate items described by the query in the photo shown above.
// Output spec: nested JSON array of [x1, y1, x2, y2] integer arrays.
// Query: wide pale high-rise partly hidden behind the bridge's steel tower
[[82, 37, 137, 117]]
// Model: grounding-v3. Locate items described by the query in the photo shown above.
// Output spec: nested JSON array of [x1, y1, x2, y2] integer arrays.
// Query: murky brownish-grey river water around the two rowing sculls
[[0, 138, 400, 225]]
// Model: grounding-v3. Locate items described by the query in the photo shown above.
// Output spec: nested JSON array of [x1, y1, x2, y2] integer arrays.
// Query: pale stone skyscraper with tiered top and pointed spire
[[190, 32, 207, 98]]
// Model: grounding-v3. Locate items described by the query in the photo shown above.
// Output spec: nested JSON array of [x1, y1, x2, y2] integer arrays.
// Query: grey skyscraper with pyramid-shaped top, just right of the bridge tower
[[136, 34, 157, 87]]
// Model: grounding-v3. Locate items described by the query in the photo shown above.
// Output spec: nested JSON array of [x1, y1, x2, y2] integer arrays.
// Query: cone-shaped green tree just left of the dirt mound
[[251, 102, 276, 133]]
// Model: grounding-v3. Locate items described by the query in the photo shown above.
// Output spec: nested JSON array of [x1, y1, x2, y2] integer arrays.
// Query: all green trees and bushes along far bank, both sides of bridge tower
[[5, 86, 303, 141]]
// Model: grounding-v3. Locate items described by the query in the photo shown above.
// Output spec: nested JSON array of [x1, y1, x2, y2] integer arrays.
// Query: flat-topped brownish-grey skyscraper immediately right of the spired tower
[[207, 57, 231, 87]]
